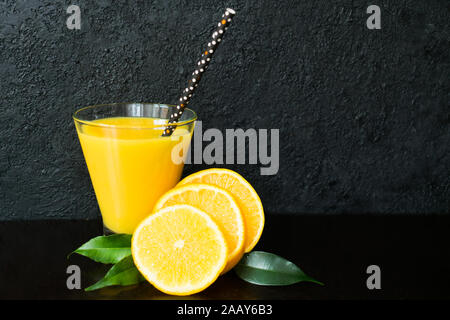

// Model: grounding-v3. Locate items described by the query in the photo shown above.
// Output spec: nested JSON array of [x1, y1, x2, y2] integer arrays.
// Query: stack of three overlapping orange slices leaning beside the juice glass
[[132, 169, 264, 295]]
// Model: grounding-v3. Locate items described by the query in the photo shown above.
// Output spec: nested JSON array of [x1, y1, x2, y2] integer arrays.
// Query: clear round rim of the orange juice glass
[[72, 102, 197, 130]]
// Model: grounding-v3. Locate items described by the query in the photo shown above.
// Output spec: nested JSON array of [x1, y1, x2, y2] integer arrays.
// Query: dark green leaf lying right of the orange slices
[[234, 251, 323, 286]]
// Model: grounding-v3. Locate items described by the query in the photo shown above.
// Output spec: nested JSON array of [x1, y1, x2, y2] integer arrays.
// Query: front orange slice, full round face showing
[[131, 205, 228, 296]]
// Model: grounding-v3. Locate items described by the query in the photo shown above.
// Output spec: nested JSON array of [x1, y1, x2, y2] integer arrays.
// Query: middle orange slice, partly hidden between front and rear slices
[[153, 184, 245, 273]]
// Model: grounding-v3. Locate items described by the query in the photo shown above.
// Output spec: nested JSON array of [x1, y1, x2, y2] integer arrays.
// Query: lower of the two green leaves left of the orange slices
[[84, 256, 145, 291]]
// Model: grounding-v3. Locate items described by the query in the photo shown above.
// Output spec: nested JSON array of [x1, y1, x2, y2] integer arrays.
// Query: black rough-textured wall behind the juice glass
[[0, 0, 450, 219]]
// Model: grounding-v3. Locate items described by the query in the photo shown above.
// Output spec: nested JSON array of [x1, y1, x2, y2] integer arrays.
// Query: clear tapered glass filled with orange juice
[[73, 103, 197, 234]]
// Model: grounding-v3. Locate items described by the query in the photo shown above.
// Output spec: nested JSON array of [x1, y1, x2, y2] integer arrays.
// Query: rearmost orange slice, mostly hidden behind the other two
[[177, 169, 265, 252]]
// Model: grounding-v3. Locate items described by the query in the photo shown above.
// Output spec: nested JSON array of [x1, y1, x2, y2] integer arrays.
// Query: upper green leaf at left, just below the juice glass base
[[69, 234, 131, 263]]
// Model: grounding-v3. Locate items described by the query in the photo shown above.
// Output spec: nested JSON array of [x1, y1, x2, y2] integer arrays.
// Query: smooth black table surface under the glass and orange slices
[[0, 214, 450, 300]]
